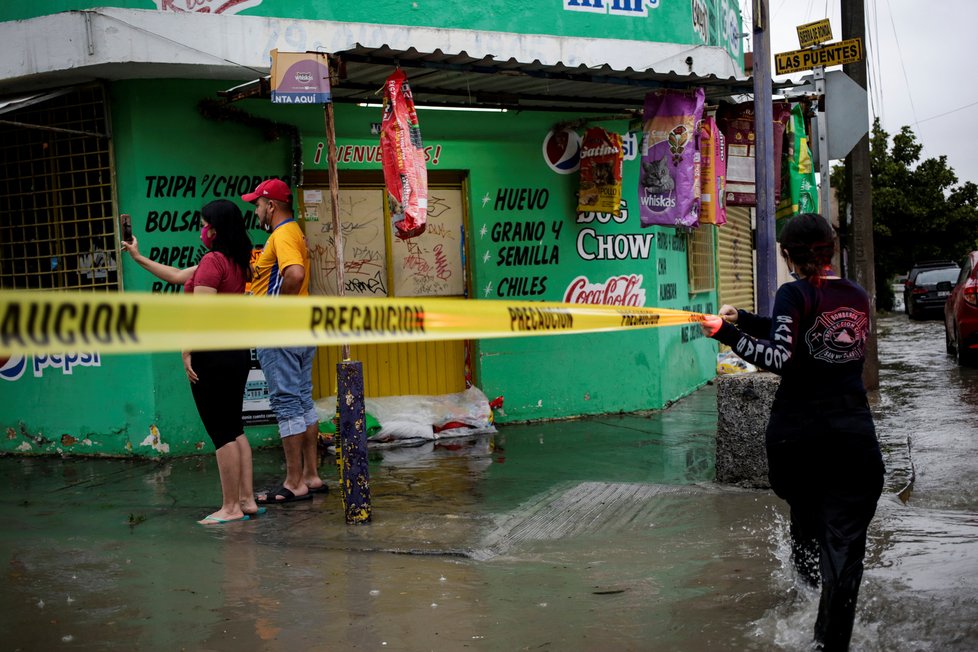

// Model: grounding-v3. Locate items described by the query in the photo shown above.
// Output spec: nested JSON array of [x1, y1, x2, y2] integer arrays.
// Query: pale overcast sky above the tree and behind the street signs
[[741, 0, 978, 188]]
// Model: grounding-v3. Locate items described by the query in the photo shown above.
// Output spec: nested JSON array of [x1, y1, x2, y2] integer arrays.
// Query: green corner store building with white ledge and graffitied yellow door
[[0, 0, 750, 455]]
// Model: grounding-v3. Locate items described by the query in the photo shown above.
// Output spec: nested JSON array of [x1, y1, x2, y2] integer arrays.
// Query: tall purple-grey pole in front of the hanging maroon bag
[[751, 0, 778, 315]]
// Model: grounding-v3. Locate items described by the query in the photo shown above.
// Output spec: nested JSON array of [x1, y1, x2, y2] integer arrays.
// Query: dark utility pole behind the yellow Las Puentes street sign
[[840, 0, 880, 389]]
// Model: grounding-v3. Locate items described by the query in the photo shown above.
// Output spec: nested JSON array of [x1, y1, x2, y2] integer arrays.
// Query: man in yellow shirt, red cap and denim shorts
[[241, 179, 327, 505]]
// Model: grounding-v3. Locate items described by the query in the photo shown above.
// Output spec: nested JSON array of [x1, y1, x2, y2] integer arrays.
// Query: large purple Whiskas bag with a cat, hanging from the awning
[[638, 88, 705, 227]]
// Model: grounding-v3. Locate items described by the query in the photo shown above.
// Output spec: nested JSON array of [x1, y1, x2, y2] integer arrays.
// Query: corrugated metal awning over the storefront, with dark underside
[[222, 44, 794, 113]]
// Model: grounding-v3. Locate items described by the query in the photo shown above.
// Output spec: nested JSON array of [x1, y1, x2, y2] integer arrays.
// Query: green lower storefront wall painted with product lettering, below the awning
[[0, 75, 716, 456]]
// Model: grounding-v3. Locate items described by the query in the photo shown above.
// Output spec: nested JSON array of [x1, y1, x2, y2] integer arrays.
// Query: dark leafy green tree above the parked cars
[[832, 118, 978, 310]]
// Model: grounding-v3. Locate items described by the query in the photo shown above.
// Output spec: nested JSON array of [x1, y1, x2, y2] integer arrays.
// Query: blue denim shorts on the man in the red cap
[[255, 346, 319, 439]]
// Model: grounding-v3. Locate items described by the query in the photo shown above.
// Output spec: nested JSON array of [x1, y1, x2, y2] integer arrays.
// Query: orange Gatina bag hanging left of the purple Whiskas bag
[[577, 127, 625, 215]]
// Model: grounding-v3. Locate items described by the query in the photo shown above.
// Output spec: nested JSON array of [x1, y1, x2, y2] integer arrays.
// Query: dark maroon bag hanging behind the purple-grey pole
[[717, 102, 791, 206]]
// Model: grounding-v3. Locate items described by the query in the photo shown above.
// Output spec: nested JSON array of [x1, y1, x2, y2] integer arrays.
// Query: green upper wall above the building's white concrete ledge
[[0, 0, 744, 63]]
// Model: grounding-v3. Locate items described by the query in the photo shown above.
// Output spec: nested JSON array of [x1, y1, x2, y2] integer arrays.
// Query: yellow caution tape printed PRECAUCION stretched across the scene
[[0, 290, 703, 356]]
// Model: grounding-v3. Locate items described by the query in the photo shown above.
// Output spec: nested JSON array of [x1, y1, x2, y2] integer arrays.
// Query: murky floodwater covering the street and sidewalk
[[0, 313, 978, 651]]
